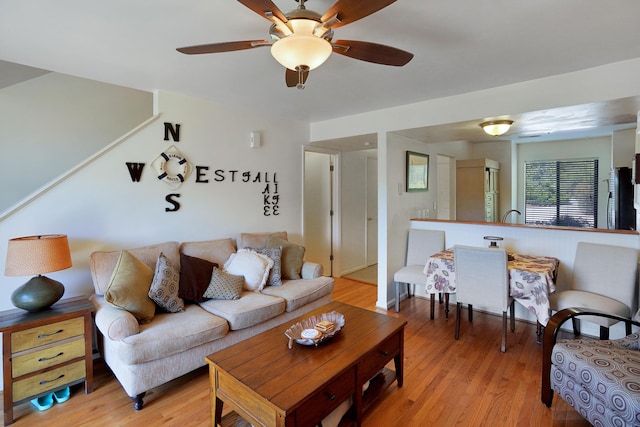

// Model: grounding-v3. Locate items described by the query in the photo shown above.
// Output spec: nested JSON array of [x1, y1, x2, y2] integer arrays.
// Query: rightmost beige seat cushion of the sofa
[[262, 277, 333, 312]]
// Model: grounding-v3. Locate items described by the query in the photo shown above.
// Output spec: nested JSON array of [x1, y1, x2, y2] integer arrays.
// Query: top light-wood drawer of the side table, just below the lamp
[[11, 317, 84, 353]]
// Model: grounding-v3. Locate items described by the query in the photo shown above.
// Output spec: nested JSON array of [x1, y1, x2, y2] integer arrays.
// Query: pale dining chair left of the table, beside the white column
[[393, 228, 444, 312]]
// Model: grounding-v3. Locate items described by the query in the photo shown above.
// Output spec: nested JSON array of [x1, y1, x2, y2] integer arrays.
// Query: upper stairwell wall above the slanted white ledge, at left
[[0, 73, 153, 216]]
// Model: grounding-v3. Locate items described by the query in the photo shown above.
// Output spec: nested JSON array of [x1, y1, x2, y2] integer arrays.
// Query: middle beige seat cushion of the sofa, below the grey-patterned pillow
[[200, 288, 286, 330]]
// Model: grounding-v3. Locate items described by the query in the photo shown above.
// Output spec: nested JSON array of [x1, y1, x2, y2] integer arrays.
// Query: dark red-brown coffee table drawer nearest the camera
[[296, 369, 356, 426]]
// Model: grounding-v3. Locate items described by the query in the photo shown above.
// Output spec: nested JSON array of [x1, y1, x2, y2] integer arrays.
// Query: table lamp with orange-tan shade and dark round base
[[4, 234, 71, 312]]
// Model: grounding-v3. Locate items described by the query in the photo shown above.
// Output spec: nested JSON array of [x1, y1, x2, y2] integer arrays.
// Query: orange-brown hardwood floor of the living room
[[1, 279, 589, 427]]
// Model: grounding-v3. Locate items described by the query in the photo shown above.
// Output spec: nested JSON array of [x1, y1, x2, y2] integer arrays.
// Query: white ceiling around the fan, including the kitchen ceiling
[[0, 0, 640, 140]]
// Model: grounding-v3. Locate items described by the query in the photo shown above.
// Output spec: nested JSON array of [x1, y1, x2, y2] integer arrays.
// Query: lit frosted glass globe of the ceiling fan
[[271, 34, 332, 71]]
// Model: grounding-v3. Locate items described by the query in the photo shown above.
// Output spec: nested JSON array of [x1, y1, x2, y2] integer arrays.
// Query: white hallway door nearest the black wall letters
[[304, 151, 333, 276]]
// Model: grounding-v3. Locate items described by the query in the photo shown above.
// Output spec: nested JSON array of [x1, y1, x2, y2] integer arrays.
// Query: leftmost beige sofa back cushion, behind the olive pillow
[[89, 242, 180, 295]]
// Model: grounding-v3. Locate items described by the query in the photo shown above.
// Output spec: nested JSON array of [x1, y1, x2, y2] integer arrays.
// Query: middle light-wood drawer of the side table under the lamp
[[11, 338, 85, 378]]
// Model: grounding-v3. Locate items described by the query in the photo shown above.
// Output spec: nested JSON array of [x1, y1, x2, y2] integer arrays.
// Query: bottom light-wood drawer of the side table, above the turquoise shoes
[[13, 360, 87, 402]]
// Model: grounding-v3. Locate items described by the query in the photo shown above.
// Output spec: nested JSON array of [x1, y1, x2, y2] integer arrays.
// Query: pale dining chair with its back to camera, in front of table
[[453, 245, 515, 353]]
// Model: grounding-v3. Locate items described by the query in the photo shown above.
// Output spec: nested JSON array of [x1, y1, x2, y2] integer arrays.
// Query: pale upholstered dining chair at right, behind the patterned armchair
[[549, 242, 638, 340]]
